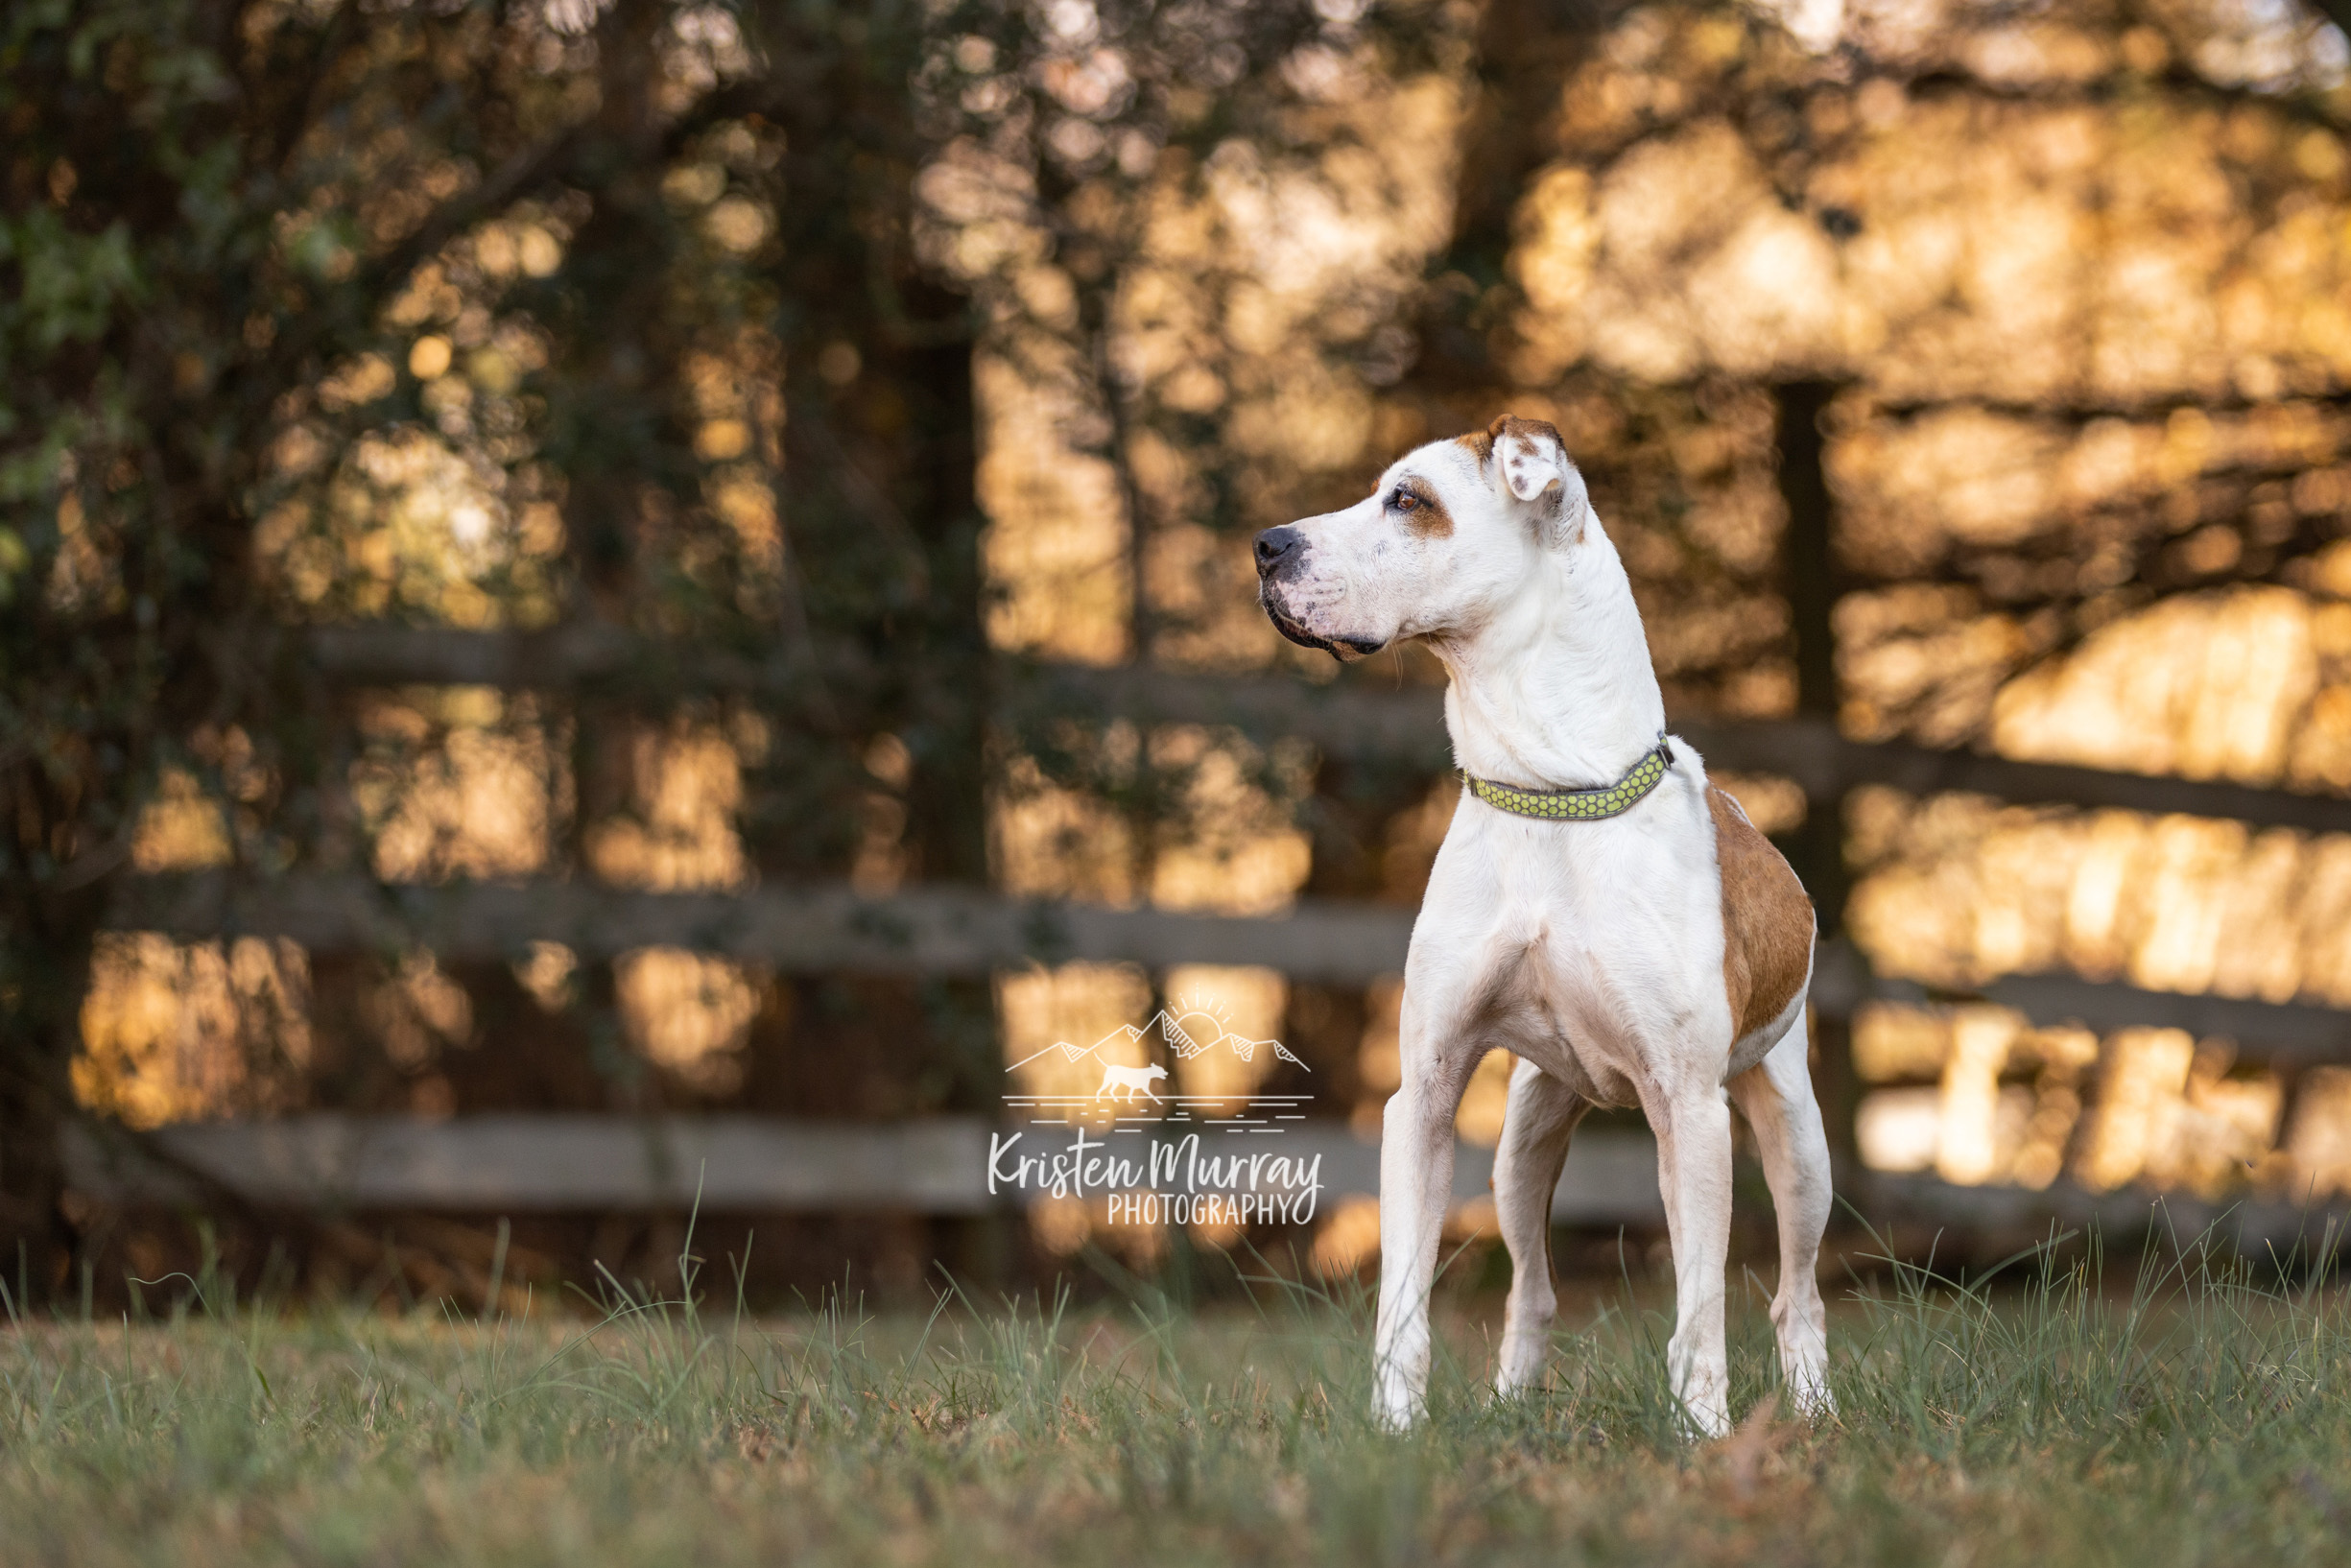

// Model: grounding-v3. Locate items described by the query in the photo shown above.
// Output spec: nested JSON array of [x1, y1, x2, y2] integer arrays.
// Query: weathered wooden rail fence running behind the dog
[[96, 626, 2351, 1244]]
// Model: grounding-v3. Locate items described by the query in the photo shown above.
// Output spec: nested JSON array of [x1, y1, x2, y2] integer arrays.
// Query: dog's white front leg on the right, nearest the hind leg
[[1648, 1081, 1730, 1437]]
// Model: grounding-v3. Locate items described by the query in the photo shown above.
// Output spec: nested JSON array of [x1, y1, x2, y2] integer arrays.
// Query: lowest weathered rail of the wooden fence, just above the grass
[[63, 1114, 2346, 1258]]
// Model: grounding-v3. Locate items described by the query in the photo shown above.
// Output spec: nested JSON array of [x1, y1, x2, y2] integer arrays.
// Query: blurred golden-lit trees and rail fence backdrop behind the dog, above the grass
[[0, 0, 2351, 1305]]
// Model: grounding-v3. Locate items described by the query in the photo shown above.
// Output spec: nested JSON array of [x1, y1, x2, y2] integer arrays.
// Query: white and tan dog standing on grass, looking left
[[1258, 418, 1829, 1434]]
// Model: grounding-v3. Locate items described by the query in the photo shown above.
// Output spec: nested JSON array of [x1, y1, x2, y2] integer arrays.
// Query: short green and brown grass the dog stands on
[[0, 1265, 2351, 1568]]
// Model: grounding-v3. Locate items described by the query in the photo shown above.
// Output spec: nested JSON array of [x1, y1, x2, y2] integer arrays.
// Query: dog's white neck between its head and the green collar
[[1430, 517, 1665, 790]]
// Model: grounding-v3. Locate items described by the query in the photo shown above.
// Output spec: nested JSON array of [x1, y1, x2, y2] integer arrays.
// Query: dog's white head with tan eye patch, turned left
[[1258, 414, 1592, 660]]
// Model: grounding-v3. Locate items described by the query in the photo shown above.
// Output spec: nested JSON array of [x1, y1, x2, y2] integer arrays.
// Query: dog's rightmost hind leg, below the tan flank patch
[[1730, 1009, 1836, 1415]]
